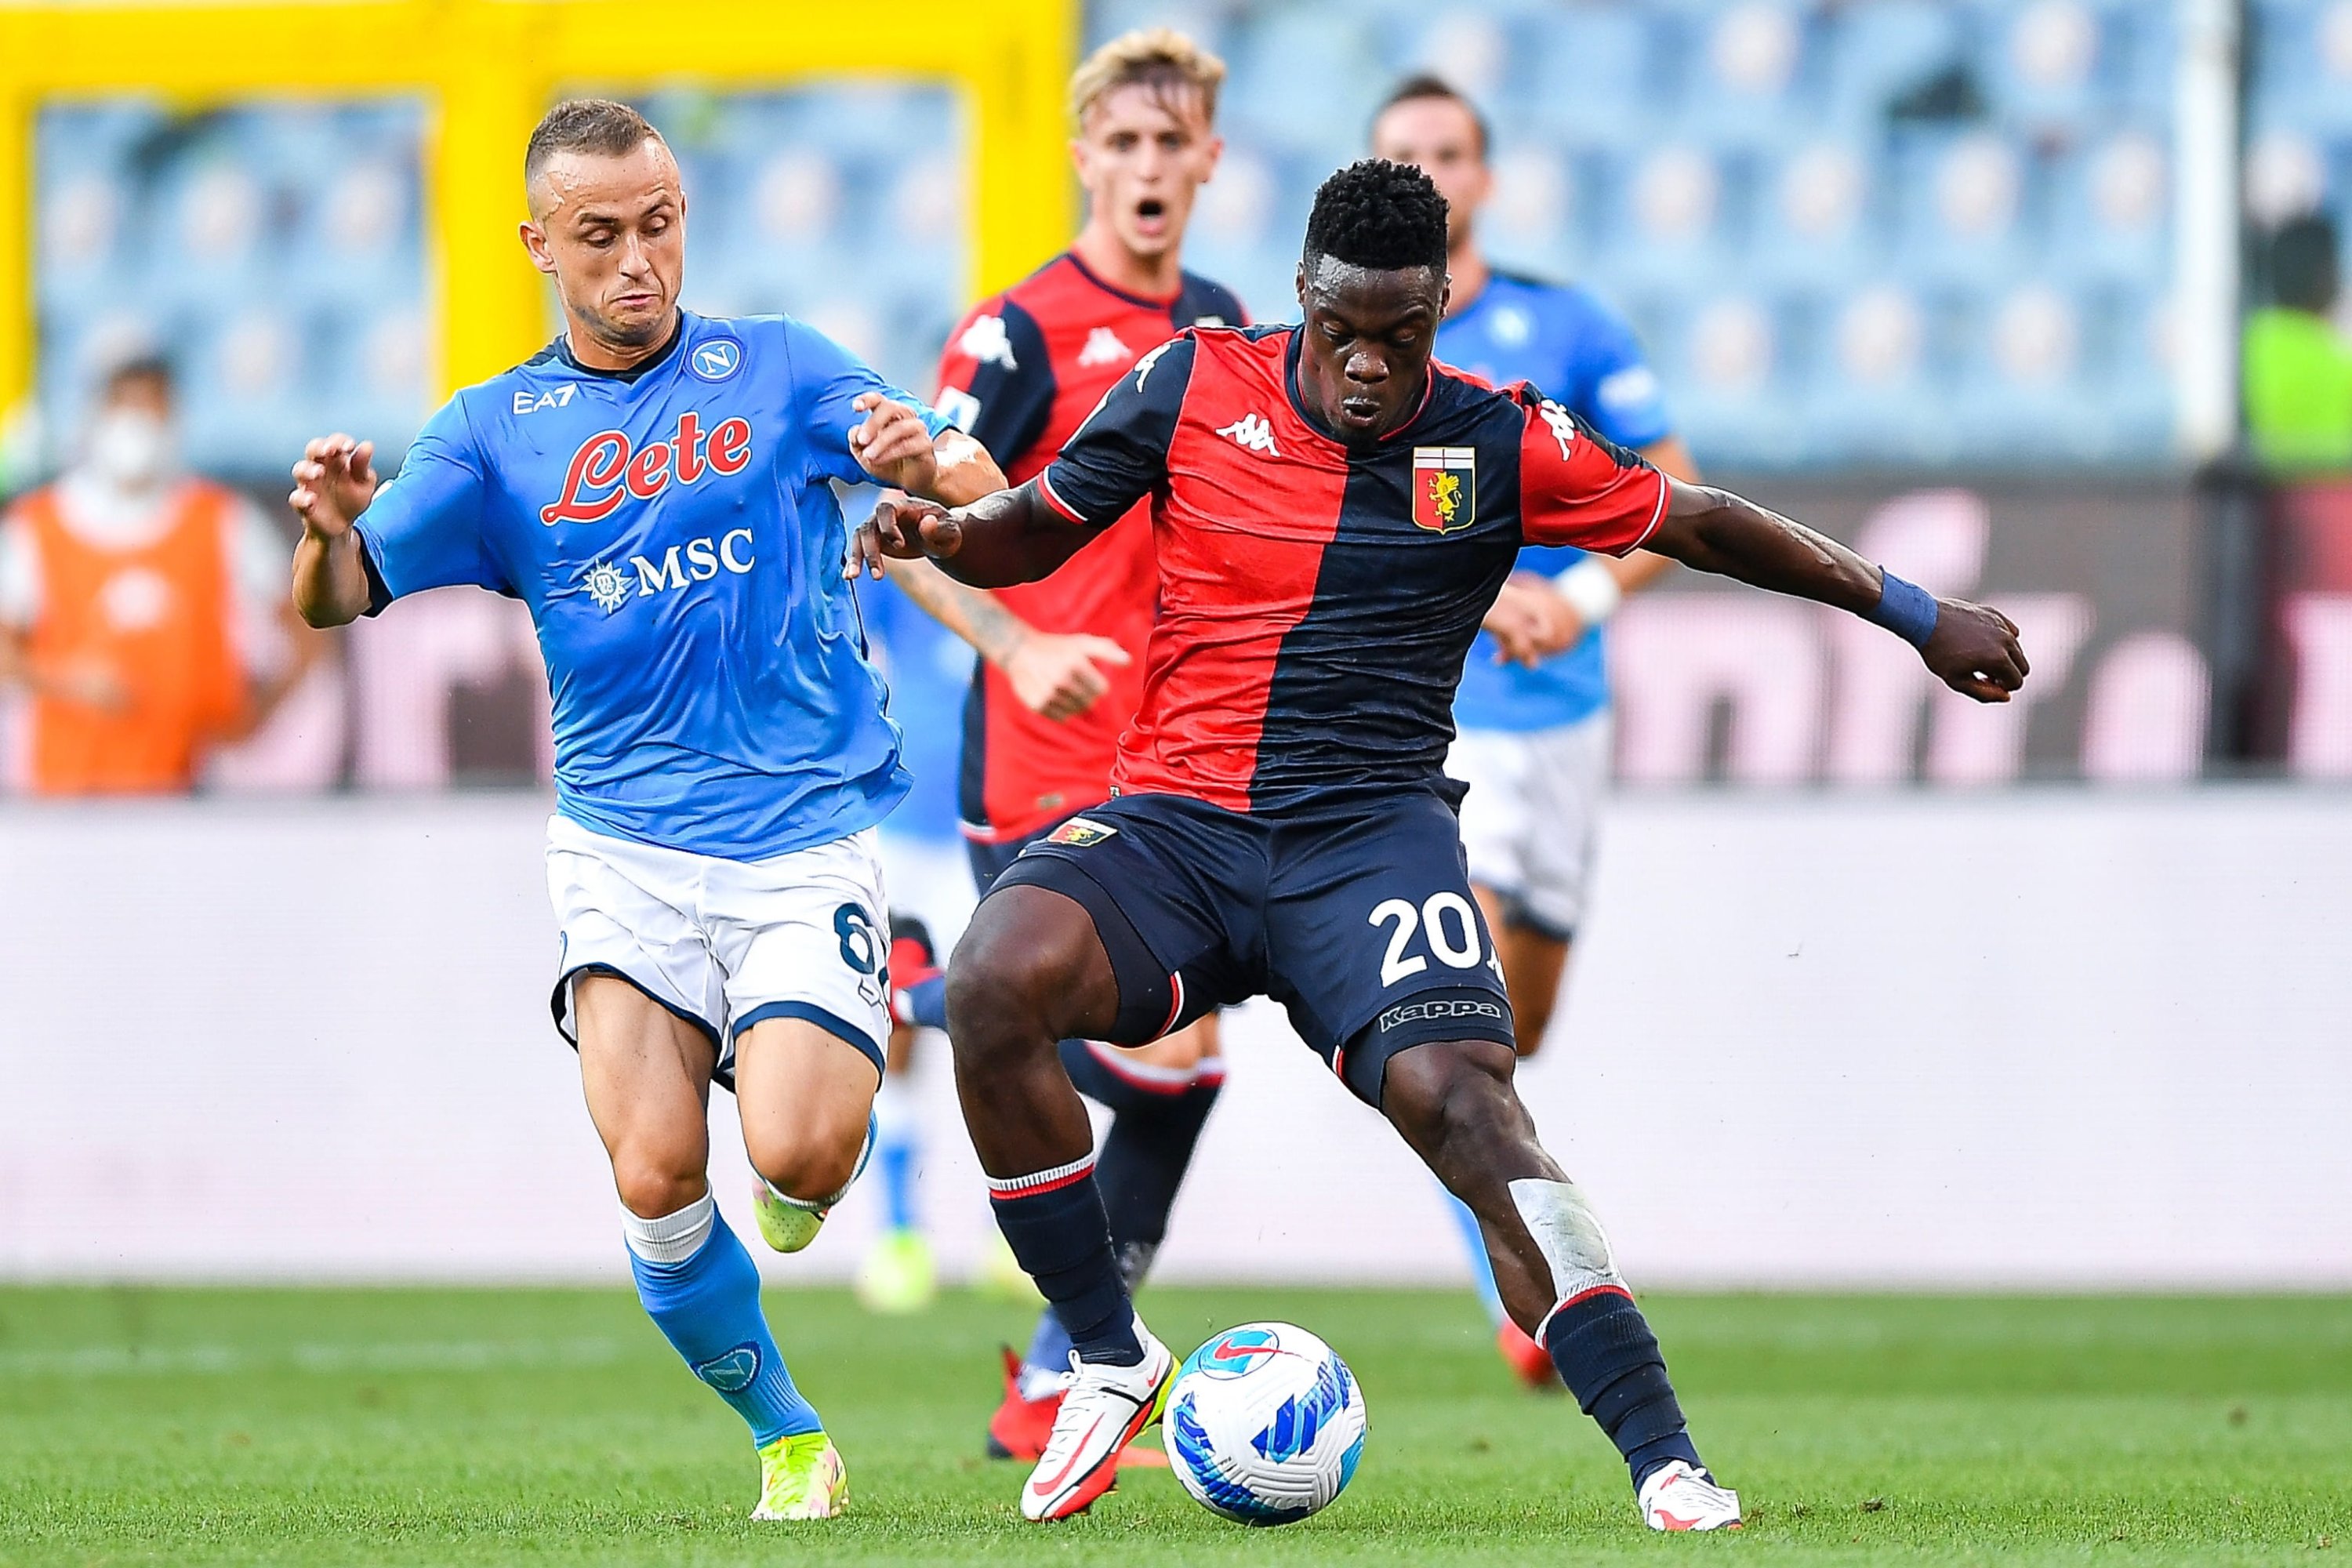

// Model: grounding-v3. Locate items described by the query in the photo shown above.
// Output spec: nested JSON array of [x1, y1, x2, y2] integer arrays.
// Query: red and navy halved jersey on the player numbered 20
[[1040, 327, 1668, 813]]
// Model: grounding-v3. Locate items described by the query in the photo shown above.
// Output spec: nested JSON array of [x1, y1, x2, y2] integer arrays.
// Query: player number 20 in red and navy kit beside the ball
[[856, 160, 2027, 1530]]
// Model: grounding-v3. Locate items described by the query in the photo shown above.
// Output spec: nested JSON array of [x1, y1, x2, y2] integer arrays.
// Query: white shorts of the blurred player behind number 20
[[1446, 708, 1611, 940]]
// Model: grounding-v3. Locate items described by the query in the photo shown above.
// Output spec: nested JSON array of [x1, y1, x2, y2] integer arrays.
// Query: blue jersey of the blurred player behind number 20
[[1437, 273, 1675, 731]]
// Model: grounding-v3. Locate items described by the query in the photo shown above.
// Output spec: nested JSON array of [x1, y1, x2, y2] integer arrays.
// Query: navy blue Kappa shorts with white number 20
[[993, 789, 1515, 1107]]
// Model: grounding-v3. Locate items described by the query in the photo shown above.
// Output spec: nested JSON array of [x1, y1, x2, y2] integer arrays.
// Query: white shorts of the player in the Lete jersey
[[548, 815, 889, 1088]]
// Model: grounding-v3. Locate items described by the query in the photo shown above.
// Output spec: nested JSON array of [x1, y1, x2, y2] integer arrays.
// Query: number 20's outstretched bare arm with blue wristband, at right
[[1642, 480, 2030, 703]]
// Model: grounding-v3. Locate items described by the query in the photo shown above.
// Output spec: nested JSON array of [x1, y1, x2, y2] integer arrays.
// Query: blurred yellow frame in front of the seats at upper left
[[0, 0, 1080, 412]]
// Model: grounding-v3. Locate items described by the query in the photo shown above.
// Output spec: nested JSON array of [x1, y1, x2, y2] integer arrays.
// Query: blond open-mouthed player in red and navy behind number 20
[[884, 31, 1244, 1460]]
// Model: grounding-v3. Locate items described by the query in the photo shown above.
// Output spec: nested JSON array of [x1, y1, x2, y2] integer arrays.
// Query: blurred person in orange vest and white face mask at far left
[[0, 360, 325, 794]]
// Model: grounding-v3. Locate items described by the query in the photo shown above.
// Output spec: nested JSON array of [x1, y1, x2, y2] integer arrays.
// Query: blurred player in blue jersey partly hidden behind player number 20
[[1371, 75, 1698, 1387]]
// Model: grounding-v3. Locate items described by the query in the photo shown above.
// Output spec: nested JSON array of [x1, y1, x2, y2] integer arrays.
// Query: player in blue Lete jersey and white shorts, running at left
[[292, 101, 1004, 1519]]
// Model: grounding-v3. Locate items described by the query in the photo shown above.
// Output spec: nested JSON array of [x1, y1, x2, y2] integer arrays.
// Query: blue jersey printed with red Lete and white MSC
[[360, 313, 946, 860]]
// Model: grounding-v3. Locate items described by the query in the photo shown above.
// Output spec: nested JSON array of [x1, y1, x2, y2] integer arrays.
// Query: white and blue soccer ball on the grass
[[1162, 1323, 1364, 1523]]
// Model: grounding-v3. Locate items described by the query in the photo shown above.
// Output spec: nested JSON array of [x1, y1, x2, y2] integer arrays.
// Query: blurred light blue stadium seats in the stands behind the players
[[18, 0, 2352, 473]]
